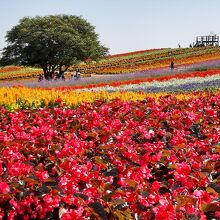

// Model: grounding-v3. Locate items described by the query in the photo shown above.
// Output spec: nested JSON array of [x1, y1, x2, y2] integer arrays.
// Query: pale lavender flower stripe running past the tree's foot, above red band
[[0, 59, 217, 89]]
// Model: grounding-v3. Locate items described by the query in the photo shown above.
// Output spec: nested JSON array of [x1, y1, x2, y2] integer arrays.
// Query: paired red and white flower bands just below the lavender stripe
[[54, 70, 220, 92]]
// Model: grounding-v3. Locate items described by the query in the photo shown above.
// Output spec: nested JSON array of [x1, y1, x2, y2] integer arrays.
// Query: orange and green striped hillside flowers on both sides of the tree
[[0, 47, 220, 81]]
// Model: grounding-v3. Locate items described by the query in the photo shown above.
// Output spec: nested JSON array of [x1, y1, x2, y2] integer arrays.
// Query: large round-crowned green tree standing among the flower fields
[[0, 15, 108, 79]]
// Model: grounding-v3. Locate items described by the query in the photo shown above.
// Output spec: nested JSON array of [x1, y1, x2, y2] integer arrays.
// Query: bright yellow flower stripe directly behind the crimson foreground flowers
[[0, 87, 211, 110]]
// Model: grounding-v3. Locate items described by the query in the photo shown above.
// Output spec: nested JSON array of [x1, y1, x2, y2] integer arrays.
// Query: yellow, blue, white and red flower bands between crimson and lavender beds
[[0, 70, 220, 111]]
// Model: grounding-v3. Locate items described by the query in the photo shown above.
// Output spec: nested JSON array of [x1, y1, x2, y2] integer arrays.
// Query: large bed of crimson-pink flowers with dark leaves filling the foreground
[[0, 93, 220, 220]]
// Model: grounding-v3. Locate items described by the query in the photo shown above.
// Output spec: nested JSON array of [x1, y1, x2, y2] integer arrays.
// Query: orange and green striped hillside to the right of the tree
[[74, 47, 220, 74]]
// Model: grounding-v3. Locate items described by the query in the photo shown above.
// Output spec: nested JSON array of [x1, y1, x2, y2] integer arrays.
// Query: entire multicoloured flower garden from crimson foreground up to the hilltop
[[0, 48, 220, 220]]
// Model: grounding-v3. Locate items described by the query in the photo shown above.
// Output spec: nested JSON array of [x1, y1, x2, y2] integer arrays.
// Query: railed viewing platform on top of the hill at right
[[193, 34, 219, 47]]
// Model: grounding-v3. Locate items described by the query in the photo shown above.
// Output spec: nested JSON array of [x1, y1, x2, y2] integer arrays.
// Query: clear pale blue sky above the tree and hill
[[0, 0, 220, 54]]
